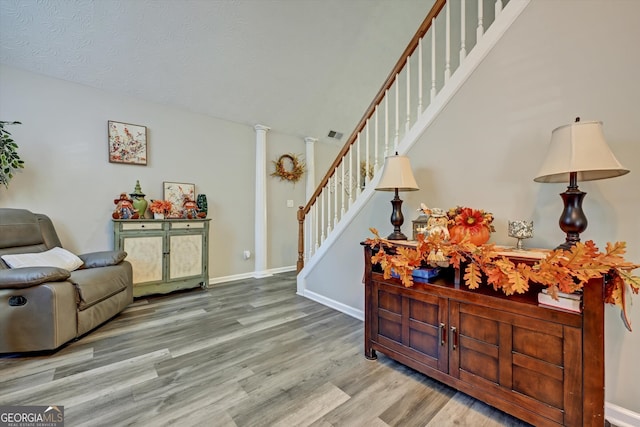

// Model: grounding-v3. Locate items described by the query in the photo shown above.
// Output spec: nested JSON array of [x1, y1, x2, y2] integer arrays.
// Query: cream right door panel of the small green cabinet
[[169, 234, 203, 280]]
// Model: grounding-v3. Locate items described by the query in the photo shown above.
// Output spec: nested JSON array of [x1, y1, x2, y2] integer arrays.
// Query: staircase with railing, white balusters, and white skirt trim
[[297, 0, 530, 318]]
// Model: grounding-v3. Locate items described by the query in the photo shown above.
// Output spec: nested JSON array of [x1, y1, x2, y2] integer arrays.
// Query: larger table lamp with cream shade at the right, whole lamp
[[534, 117, 629, 250]]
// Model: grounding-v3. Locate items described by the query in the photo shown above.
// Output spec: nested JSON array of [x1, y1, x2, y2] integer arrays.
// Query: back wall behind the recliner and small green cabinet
[[0, 66, 304, 280]]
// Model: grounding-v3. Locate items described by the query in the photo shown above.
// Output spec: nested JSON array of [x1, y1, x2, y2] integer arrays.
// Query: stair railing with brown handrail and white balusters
[[296, 0, 508, 272]]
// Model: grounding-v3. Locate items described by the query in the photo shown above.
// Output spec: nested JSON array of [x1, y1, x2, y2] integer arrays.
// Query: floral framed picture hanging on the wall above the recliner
[[108, 120, 147, 166]]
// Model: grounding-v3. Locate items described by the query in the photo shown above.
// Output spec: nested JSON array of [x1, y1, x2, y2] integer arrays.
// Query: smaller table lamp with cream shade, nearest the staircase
[[376, 153, 419, 240]]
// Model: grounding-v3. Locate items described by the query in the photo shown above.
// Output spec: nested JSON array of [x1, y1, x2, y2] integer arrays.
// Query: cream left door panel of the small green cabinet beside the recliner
[[121, 235, 163, 284]]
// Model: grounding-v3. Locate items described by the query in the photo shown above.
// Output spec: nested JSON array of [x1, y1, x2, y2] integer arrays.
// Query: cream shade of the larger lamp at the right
[[534, 121, 629, 183]]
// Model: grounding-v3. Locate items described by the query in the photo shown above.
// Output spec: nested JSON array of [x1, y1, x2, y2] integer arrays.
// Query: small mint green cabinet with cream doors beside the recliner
[[113, 219, 210, 297]]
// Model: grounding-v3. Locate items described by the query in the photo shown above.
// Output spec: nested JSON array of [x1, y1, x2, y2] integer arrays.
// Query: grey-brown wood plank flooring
[[0, 273, 604, 427]]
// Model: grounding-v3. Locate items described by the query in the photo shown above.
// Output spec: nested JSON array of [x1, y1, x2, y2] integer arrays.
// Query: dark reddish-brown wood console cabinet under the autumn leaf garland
[[364, 246, 604, 427]]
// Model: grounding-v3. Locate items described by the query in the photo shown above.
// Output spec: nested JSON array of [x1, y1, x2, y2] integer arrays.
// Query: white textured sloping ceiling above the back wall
[[0, 0, 433, 144]]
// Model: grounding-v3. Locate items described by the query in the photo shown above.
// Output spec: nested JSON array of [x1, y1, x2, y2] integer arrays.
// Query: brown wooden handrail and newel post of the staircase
[[296, 0, 447, 272]]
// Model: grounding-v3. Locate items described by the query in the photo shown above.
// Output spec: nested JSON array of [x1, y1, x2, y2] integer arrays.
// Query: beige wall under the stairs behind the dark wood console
[[306, 0, 640, 413]]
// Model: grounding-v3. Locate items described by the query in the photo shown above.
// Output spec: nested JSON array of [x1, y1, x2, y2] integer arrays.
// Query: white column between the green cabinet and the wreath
[[253, 125, 272, 278]]
